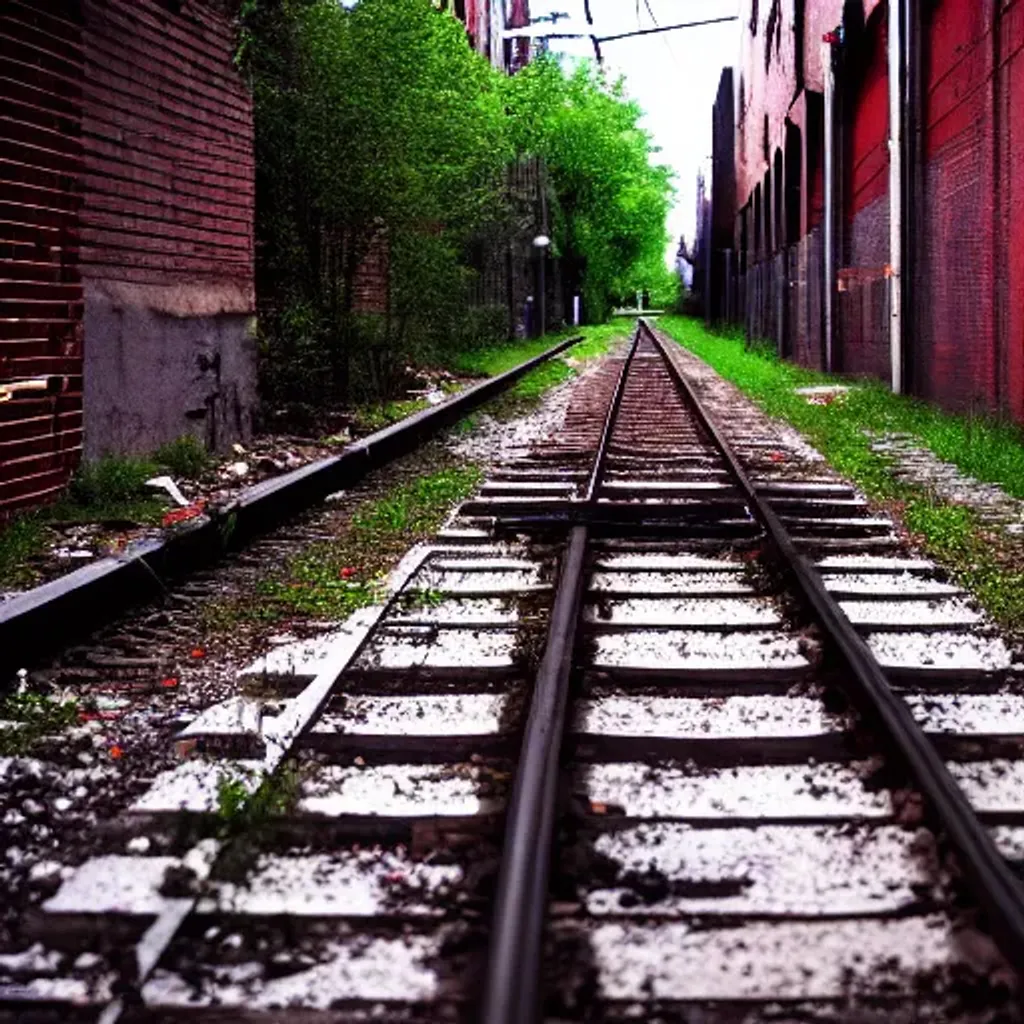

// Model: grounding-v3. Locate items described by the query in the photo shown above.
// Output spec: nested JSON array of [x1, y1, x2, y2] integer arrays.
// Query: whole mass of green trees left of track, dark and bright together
[[238, 6, 671, 406]]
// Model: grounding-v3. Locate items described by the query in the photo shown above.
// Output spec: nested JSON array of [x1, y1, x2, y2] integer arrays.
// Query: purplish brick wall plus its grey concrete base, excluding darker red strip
[[81, 0, 256, 457]]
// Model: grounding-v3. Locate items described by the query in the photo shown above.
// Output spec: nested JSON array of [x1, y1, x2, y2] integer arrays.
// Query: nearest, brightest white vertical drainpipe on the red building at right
[[888, 0, 906, 394]]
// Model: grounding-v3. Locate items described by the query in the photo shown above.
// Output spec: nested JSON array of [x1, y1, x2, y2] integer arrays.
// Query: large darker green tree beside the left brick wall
[[240, 0, 511, 402]]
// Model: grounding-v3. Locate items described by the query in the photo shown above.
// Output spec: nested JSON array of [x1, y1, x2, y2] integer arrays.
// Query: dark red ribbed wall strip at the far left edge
[[0, 0, 83, 518]]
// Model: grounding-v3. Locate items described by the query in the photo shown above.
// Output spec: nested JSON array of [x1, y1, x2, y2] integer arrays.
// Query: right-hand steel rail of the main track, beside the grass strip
[[638, 321, 1024, 973]]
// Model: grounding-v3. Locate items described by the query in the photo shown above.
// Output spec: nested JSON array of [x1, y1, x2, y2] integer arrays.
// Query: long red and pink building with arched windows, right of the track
[[709, 0, 1024, 420]]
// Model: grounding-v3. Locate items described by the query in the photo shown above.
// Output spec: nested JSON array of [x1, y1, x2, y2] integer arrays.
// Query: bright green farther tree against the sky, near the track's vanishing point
[[505, 57, 672, 323]]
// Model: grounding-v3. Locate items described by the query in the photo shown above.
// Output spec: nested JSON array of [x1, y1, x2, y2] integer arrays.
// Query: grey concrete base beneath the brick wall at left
[[85, 282, 256, 459]]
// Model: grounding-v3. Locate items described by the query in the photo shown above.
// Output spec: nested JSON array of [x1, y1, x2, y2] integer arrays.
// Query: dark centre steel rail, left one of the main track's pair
[[480, 327, 640, 1024]]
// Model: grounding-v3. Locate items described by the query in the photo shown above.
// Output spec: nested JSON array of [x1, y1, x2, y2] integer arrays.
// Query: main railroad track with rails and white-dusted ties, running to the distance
[[4, 324, 1024, 1024]]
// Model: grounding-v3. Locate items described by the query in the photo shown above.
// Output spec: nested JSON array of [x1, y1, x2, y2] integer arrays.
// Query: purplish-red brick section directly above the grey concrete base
[[76, 0, 255, 291]]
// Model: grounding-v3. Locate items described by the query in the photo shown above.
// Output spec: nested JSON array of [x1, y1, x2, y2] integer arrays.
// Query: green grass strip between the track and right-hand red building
[[658, 316, 1024, 634]]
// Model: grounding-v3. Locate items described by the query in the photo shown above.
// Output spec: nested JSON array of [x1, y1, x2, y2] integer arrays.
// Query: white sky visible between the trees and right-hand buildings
[[529, 0, 739, 262]]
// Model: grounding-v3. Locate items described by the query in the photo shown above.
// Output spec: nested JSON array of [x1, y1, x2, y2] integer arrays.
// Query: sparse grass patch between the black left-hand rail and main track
[[205, 466, 481, 632]]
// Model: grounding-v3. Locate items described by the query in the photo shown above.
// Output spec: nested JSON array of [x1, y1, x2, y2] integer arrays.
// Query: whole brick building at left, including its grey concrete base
[[0, 0, 256, 516]]
